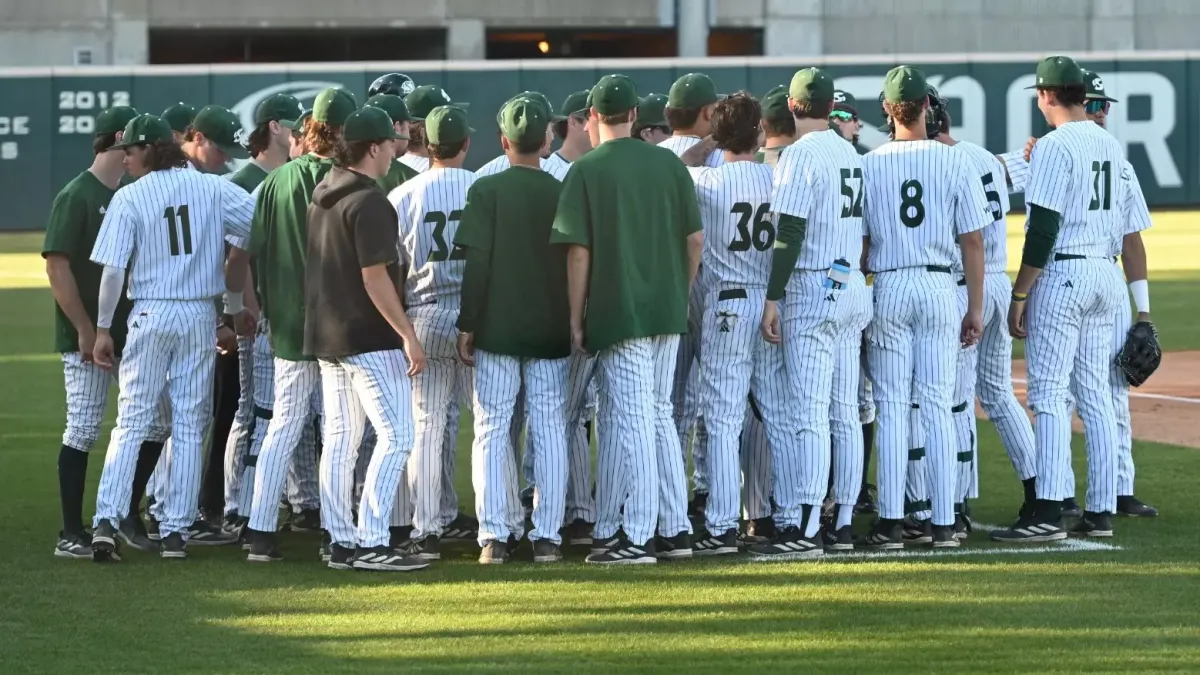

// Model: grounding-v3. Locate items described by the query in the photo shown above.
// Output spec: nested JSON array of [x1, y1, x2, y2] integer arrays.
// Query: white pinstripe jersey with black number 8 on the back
[[863, 141, 992, 271]]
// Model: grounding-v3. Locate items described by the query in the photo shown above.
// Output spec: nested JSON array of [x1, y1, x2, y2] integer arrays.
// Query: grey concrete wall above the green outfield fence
[[0, 0, 1200, 66]]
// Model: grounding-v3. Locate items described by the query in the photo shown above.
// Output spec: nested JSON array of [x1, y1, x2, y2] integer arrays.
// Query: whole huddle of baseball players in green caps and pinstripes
[[43, 56, 1157, 571]]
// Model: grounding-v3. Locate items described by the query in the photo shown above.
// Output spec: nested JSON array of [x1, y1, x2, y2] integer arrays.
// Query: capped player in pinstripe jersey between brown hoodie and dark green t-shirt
[[388, 103, 475, 560]]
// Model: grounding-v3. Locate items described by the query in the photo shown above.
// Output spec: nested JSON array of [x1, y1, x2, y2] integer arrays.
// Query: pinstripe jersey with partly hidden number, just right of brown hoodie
[[388, 168, 475, 306]]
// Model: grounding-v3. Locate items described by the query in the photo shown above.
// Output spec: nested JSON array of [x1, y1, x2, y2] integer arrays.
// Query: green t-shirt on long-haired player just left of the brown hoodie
[[250, 154, 334, 362]]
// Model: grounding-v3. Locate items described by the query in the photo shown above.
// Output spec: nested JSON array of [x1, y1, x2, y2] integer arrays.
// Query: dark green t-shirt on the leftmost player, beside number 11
[[42, 171, 133, 354]]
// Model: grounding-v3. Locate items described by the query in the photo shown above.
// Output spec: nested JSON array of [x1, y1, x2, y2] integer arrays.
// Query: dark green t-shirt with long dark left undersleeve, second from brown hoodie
[[454, 166, 571, 359]]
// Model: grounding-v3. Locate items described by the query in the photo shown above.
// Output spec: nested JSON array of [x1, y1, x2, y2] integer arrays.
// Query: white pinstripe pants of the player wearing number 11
[[94, 300, 216, 538]]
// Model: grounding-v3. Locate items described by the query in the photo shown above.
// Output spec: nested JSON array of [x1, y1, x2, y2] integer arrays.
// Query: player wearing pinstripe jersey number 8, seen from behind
[[863, 66, 994, 550]]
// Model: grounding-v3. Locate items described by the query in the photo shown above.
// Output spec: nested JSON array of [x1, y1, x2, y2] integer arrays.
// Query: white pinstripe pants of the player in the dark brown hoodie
[[319, 350, 413, 548]]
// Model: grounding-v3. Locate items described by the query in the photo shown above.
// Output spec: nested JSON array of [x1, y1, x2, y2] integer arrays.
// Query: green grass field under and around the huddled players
[[0, 213, 1200, 674]]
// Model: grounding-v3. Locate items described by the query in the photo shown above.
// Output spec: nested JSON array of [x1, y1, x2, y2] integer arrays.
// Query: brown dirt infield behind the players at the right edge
[[1003, 352, 1200, 448]]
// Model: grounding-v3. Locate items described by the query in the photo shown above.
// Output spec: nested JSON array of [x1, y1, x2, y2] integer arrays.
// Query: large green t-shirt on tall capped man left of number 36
[[551, 138, 701, 352]]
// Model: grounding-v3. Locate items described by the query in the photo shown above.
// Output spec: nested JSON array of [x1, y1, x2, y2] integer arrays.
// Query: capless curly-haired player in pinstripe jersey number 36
[[692, 91, 798, 555]]
